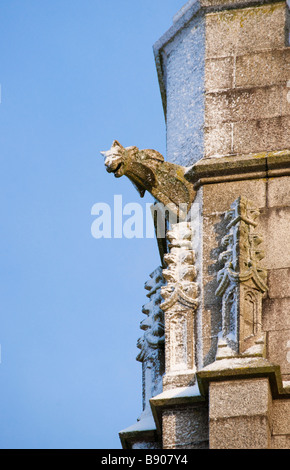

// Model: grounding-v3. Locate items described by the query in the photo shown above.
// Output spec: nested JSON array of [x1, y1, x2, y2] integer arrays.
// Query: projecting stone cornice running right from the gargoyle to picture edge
[[185, 150, 290, 190]]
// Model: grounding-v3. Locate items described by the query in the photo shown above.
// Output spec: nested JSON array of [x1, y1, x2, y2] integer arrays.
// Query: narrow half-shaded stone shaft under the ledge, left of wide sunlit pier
[[162, 405, 208, 449]]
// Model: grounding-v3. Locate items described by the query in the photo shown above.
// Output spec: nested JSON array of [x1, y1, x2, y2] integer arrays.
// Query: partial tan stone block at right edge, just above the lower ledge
[[267, 329, 290, 380]]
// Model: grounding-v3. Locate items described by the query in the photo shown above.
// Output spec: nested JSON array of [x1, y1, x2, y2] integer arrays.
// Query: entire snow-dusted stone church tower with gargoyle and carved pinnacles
[[110, 0, 290, 449]]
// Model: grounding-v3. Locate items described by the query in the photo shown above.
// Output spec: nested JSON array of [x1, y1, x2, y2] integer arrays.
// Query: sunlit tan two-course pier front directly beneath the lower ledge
[[209, 379, 272, 449]]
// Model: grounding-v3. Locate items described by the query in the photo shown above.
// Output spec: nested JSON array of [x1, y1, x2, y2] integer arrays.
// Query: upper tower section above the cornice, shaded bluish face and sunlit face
[[155, 0, 290, 166]]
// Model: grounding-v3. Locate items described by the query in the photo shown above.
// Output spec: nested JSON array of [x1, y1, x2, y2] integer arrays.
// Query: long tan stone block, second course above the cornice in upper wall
[[205, 86, 281, 126]]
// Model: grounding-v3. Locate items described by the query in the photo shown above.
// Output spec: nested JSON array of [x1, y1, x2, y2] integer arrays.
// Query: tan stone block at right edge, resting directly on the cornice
[[233, 116, 290, 154]]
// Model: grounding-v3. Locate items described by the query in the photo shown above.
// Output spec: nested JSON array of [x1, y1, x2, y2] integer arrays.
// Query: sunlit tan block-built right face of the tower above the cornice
[[204, 2, 290, 157]]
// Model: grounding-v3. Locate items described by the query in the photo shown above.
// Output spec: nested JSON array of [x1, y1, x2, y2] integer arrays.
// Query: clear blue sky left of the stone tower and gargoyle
[[0, 0, 185, 449]]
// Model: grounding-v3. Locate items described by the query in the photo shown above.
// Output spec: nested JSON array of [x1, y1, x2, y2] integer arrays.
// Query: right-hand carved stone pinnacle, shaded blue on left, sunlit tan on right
[[216, 197, 267, 353]]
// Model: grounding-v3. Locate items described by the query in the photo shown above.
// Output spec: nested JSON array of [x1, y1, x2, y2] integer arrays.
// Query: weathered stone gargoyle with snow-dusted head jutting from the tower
[[101, 140, 195, 219]]
